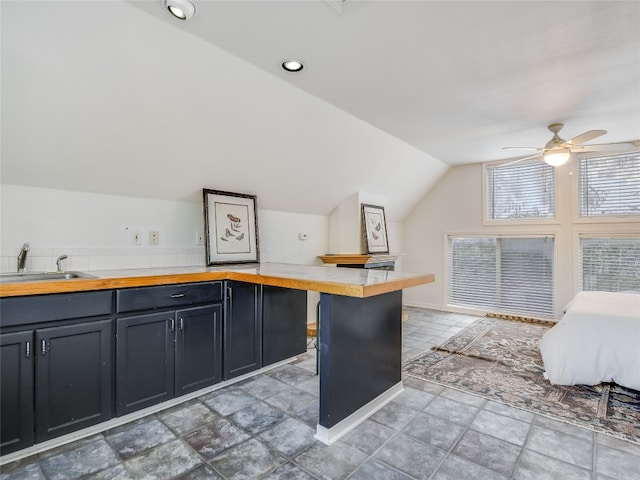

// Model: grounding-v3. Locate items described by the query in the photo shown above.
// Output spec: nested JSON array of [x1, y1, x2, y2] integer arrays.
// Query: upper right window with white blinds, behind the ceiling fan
[[578, 153, 640, 217]]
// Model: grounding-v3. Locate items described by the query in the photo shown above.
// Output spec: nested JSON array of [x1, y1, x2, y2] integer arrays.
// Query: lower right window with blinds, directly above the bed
[[580, 235, 640, 292]]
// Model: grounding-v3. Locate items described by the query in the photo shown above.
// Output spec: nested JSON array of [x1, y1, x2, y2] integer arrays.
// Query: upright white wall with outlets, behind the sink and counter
[[0, 184, 328, 272]]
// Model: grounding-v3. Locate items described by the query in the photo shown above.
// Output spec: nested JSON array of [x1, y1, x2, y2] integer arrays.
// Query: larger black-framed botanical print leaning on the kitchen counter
[[202, 188, 260, 266]]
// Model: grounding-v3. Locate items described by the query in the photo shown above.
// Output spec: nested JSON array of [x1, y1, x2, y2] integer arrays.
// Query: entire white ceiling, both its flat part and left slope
[[0, 0, 640, 220]]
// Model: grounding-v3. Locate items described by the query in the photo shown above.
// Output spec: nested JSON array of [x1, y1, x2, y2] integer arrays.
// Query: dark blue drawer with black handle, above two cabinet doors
[[116, 282, 222, 313]]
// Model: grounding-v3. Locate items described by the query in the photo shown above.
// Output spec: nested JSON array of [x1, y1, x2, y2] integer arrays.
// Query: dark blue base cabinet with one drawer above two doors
[[116, 282, 222, 416]]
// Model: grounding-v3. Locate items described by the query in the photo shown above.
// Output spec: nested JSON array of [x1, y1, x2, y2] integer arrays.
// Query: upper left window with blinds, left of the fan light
[[485, 161, 556, 221]]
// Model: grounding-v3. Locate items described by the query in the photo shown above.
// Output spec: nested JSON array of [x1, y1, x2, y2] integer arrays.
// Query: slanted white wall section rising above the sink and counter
[[0, 0, 447, 221]]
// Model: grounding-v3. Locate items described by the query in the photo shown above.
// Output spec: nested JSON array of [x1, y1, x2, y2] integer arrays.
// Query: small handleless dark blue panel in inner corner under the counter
[[262, 285, 307, 366]]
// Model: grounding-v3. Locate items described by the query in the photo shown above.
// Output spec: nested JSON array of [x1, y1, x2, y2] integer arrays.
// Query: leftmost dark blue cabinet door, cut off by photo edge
[[0, 330, 33, 455]]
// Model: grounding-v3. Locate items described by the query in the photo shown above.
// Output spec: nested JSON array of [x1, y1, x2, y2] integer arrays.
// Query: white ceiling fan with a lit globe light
[[503, 123, 640, 167]]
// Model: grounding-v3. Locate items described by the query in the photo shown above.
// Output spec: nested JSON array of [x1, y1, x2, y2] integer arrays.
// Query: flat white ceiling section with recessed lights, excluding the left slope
[[126, 0, 640, 165]]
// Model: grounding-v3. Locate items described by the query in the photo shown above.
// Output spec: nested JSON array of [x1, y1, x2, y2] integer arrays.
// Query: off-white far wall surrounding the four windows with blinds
[[403, 164, 640, 318]]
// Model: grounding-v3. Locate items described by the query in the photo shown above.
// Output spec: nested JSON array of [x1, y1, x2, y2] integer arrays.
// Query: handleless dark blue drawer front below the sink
[[0, 290, 113, 327]]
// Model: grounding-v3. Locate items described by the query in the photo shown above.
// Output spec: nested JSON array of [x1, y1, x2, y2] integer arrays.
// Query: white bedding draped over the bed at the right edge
[[540, 292, 640, 390]]
